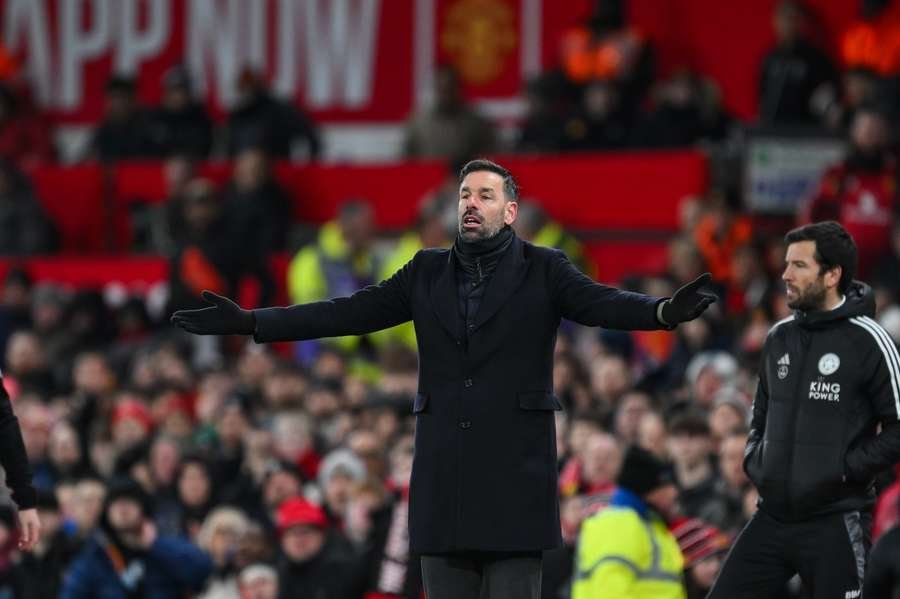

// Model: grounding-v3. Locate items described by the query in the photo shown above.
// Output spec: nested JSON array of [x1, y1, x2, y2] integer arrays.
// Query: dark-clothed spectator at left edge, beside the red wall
[[0, 161, 56, 256]]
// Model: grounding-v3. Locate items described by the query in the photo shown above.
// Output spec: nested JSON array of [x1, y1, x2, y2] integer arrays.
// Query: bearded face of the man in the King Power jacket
[[781, 241, 841, 311]]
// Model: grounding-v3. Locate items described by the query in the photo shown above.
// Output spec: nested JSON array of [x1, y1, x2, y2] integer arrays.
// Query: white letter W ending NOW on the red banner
[[303, 0, 381, 108]]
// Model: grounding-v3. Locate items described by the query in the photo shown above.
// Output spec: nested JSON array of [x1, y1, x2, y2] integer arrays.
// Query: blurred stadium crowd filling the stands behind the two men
[[0, 0, 900, 599]]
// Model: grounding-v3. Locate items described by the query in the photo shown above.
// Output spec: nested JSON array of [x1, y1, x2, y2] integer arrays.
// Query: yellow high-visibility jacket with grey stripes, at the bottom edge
[[572, 489, 687, 599]]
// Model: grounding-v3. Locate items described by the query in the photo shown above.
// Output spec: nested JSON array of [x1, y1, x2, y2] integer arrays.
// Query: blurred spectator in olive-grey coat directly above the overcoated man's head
[[404, 66, 494, 160]]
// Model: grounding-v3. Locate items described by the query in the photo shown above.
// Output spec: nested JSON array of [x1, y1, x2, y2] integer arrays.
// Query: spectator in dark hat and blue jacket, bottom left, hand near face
[[59, 478, 213, 599]]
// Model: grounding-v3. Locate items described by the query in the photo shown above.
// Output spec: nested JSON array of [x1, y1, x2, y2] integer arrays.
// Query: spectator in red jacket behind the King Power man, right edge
[[801, 106, 900, 279]]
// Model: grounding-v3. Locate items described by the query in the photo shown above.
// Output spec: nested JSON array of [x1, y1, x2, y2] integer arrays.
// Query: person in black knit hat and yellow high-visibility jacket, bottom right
[[572, 445, 687, 599]]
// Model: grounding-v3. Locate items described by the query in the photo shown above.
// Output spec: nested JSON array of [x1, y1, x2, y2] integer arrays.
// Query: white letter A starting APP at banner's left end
[[3, 0, 53, 104]]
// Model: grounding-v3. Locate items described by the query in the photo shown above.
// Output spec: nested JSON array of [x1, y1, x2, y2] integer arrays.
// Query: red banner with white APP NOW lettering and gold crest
[[0, 0, 579, 123]]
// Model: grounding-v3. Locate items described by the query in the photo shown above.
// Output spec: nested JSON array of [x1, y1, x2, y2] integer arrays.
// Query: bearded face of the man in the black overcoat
[[457, 171, 519, 241]]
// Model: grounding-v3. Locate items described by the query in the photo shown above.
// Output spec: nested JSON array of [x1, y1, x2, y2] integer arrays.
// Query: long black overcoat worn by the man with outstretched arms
[[254, 238, 662, 554]]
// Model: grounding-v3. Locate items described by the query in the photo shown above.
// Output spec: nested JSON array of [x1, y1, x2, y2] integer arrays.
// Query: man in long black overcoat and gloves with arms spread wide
[[172, 160, 714, 599]]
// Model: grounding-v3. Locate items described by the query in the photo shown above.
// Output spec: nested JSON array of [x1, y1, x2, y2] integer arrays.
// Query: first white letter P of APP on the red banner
[[58, 0, 112, 109]]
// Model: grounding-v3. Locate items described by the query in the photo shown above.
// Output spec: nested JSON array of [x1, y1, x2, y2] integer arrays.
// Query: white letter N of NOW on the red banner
[[186, 0, 246, 106]]
